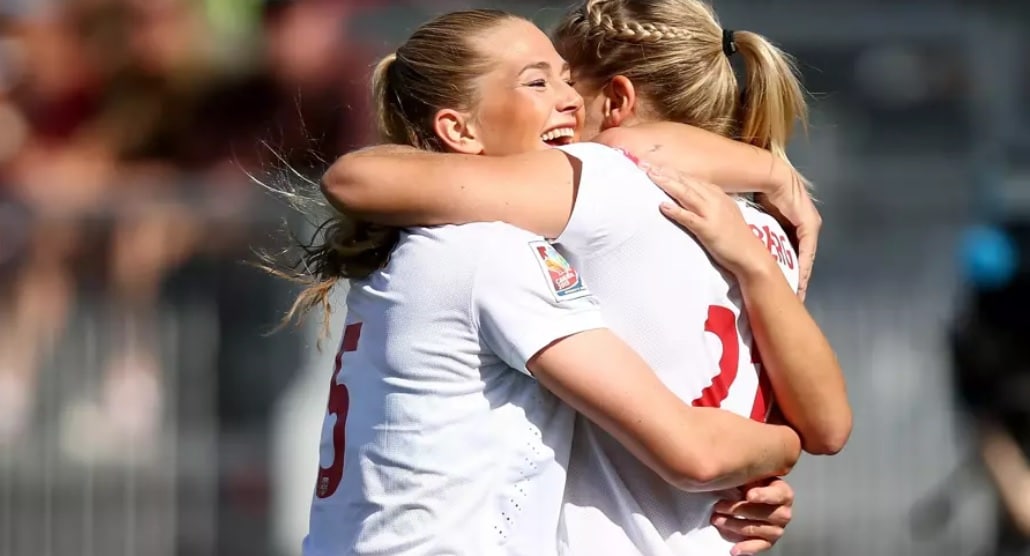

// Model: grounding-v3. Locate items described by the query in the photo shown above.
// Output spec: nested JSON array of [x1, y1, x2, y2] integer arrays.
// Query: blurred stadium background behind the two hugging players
[[0, 0, 1030, 556]]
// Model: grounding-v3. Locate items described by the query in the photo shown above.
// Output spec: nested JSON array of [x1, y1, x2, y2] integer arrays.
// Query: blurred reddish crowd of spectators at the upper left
[[0, 0, 374, 446]]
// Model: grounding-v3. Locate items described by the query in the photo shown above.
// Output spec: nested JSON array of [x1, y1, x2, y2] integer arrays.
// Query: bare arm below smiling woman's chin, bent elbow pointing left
[[322, 145, 576, 237]]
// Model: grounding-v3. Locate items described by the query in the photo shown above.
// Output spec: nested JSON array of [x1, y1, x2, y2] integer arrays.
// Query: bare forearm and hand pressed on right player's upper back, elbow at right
[[653, 175, 852, 454]]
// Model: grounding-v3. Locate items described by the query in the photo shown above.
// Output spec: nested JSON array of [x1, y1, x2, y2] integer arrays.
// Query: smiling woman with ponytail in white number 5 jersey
[[286, 10, 801, 556]]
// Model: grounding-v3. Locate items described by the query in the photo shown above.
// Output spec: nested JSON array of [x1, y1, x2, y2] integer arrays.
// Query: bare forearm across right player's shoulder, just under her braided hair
[[594, 121, 799, 193]]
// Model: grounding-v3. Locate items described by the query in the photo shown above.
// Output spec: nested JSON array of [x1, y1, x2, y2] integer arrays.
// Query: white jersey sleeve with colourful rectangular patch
[[472, 228, 605, 373]]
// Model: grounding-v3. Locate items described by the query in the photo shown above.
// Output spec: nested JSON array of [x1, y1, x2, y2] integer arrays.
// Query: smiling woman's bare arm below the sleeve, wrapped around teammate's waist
[[527, 329, 800, 491]]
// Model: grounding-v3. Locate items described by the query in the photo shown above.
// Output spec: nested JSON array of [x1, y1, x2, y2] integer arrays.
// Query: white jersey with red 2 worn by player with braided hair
[[557, 143, 797, 556]]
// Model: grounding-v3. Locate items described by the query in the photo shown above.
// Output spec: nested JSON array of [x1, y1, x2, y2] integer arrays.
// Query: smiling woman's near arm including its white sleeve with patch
[[477, 230, 800, 490]]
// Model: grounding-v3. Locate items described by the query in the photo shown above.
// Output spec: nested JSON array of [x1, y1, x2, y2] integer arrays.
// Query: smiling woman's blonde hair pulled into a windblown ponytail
[[260, 9, 517, 334]]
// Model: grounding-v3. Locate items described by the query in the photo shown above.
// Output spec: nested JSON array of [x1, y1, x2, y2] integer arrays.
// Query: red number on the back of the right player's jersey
[[691, 305, 773, 422]]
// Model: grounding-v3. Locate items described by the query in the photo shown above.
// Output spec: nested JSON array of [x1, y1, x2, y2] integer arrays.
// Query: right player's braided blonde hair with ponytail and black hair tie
[[554, 0, 808, 162]]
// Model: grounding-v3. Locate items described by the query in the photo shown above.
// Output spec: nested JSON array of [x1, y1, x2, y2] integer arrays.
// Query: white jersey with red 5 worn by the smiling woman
[[304, 223, 604, 556]]
